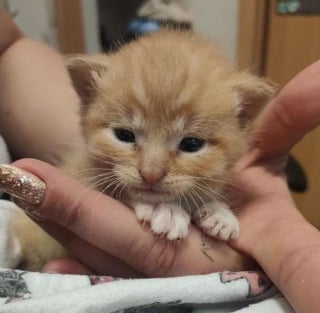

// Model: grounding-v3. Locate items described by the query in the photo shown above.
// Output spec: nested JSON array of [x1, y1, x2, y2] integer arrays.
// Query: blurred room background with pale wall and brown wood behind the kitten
[[0, 0, 320, 228]]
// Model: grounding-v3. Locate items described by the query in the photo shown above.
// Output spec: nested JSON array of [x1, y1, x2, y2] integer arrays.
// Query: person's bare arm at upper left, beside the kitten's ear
[[0, 9, 82, 163]]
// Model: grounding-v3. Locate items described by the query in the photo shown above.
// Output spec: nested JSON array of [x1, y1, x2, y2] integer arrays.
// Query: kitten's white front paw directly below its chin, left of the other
[[151, 203, 190, 240]]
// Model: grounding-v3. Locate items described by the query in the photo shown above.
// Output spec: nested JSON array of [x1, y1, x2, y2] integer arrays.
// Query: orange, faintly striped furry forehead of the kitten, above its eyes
[[100, 33, 236, 131]]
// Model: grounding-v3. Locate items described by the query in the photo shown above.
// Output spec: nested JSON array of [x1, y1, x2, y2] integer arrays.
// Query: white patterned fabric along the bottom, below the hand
[[0, 269, 293, 313]]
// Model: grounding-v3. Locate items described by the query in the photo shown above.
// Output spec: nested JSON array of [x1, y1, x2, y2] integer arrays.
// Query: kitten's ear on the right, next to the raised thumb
[[232, 73, 276, 127]]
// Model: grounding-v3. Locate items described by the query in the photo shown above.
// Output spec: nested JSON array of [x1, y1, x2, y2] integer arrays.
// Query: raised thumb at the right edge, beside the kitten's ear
[[256, 61, 320, 159]]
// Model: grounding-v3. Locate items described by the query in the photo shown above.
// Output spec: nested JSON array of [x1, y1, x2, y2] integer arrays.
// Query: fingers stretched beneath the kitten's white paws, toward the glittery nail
[[1, 159, 244, 276]]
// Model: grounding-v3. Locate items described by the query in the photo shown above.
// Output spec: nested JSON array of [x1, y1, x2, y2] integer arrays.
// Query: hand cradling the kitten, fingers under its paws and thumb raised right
[[4, 59, 320, 276]]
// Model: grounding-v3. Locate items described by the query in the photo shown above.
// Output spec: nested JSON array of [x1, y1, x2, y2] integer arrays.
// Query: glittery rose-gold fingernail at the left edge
[[0, 165, 46, 205]]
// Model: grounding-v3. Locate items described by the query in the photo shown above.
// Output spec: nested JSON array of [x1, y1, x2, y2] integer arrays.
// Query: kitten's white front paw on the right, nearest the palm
[[196, 201, 240, 240]]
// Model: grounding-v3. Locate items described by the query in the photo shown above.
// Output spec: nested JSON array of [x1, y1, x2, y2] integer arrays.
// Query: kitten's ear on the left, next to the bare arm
[[65, 55, 107, 110]]
